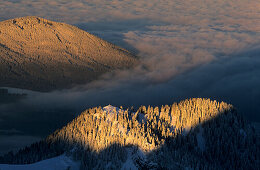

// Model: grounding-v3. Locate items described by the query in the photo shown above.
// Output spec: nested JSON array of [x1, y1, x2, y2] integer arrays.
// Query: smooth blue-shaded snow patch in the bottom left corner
[[0, 155, 80, 170]]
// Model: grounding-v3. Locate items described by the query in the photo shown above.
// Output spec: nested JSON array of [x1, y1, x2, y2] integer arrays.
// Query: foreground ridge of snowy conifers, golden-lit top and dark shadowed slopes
[[1, 98, 260, 169]]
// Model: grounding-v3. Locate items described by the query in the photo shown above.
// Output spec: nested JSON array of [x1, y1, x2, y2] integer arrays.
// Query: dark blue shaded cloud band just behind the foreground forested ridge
[[9, 45, 260, 120]]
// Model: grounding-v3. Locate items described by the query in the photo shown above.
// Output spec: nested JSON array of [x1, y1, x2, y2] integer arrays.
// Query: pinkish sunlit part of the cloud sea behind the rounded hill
[[0, 0, 260, 81]]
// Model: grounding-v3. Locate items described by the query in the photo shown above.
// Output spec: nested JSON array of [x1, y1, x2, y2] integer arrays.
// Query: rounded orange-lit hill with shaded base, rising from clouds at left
[[0, 17, 138, 91]]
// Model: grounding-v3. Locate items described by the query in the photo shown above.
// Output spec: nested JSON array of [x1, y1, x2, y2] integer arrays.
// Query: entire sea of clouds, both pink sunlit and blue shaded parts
[[0, 0, 260, 153]]
